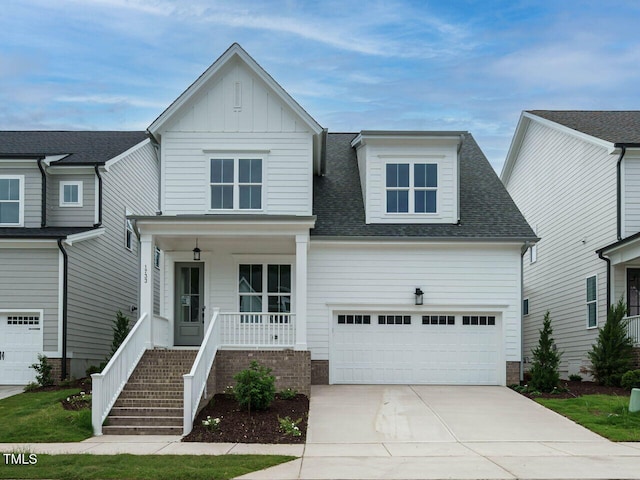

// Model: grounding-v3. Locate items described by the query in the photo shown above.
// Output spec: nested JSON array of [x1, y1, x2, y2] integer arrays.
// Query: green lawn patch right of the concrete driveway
[[536, 395, 640, 442]]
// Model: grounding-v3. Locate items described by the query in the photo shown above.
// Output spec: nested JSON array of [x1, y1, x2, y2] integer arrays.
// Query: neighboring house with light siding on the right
[[501, 110, 640, 377]]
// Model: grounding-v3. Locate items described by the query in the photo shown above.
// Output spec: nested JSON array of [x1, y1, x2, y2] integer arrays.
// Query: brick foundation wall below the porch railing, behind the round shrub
[[214, 350, 311, 396]]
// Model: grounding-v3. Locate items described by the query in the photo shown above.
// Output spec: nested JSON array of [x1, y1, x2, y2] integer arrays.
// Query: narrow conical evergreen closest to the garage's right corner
[[529, 312, 561, 392]]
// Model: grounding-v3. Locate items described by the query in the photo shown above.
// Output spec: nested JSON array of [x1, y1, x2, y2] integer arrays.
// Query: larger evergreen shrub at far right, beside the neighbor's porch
[[588, 299, 633, 387]]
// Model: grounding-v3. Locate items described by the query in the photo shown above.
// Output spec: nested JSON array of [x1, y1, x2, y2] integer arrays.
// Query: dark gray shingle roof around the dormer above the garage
[[311, 133, 536, 240]]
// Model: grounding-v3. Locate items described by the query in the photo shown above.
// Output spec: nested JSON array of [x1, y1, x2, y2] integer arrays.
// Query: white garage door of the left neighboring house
[[0, 312, 42, 385]]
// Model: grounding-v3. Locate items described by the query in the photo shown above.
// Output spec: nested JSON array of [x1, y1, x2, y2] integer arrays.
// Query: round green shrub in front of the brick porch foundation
[[233, 360, 276, 412]]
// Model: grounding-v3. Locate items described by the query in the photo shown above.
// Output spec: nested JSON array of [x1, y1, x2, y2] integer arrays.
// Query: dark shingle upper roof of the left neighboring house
[[0, 130, 147, 165]]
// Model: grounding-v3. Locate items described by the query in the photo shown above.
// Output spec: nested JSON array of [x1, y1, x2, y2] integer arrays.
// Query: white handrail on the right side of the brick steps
[[182, 308, 220, 435]]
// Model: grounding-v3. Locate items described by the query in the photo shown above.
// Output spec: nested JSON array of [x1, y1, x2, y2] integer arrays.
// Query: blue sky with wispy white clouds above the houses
[[0, 0, 640, 172]]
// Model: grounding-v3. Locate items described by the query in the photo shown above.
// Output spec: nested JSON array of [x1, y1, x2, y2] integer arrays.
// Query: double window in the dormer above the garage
[[385, 161, 438, 214]]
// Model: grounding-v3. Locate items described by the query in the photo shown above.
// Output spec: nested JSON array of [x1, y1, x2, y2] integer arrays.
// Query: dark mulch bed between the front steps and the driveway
[[182, 394, 309, 443]]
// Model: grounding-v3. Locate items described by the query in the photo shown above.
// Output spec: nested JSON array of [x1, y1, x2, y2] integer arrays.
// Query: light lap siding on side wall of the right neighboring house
[[506, 121, 616, 377]]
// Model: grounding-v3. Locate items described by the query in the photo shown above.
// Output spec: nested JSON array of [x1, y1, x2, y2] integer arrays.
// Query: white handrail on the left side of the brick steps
[[91, 313, 151, 435]]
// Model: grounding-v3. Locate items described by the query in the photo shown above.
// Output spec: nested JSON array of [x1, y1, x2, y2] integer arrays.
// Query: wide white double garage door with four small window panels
[[329, 313, 504, 385]]
